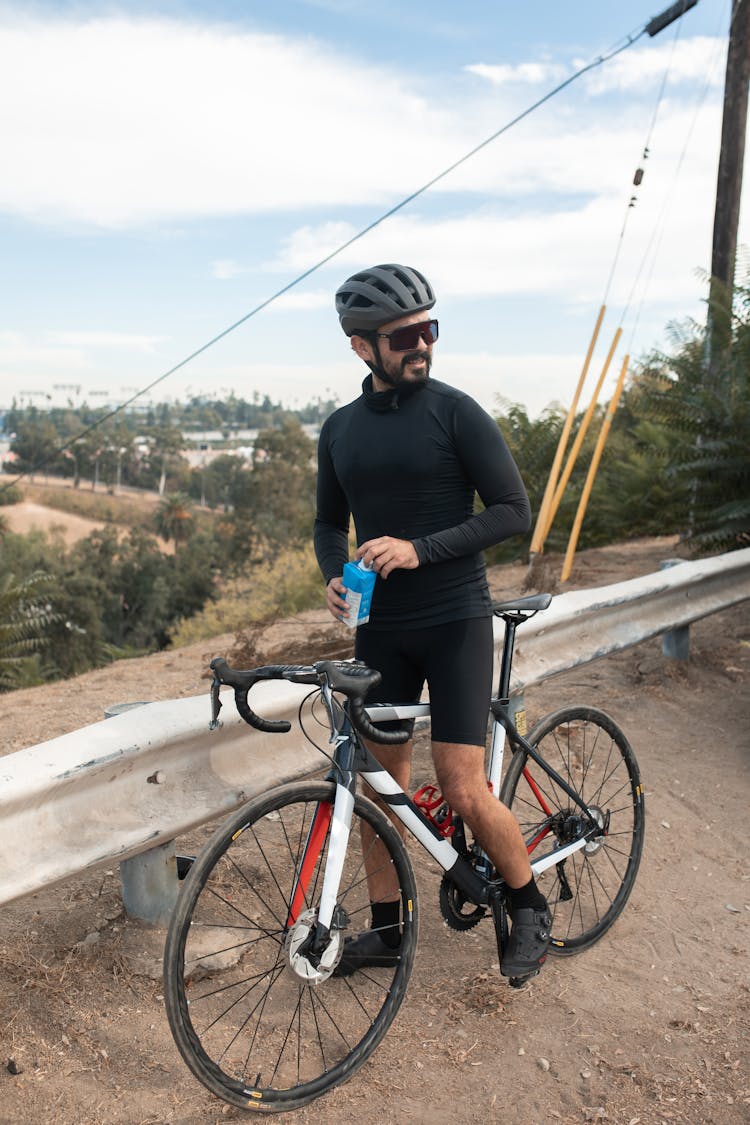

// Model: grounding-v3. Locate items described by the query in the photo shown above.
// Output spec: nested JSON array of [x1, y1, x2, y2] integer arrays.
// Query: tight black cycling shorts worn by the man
[[354, 618, 494, 746]]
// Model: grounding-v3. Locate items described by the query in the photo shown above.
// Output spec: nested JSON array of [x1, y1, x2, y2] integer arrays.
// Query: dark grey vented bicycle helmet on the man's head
[[336, 263, 435, 336]]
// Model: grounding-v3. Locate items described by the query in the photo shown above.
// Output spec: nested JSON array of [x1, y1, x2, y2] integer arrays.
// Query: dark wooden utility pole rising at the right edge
[[706, 0, 750, 364]]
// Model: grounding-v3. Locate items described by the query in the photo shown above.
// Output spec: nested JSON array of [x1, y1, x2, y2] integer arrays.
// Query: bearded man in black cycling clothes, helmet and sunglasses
[[314, 264, 551, 977]]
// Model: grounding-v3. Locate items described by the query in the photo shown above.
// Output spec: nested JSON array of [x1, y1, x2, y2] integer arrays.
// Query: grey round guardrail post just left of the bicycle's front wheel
[[105, 701, 180, 926]]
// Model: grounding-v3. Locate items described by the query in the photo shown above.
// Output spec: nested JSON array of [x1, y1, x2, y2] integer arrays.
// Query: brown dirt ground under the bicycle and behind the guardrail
[[0, 540, 750, 1125]]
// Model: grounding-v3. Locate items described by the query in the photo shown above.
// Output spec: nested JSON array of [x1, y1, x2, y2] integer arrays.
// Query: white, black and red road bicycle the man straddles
[[164, 594, 644, 1113]]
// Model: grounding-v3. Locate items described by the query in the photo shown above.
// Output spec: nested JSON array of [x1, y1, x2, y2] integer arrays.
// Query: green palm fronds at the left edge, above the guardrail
[[0, 570, 56, 691]]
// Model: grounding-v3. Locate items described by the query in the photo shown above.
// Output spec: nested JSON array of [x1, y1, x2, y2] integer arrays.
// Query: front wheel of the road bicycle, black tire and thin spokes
[[164, 782, 417, 1113]]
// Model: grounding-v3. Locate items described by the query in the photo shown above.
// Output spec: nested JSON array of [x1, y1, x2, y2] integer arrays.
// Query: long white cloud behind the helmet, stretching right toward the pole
[[275, 145, 728, 305]]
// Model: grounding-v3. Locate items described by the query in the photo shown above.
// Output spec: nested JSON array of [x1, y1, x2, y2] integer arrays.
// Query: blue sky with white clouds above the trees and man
[[0, 0, 750, 416]]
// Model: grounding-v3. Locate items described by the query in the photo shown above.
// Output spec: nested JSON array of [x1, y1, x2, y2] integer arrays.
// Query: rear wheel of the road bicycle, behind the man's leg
[[500, 707, 645, 955]]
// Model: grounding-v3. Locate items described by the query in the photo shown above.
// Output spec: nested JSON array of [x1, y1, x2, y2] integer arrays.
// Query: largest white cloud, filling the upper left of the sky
[[0, 16, 460, 227]]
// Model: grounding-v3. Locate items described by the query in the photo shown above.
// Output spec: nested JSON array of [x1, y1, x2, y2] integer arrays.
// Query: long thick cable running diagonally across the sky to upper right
[[0, 0, 697, 492]]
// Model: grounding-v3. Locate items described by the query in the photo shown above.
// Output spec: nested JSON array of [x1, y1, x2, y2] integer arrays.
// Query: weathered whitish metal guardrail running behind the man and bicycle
[[0, 549, 750, 921]]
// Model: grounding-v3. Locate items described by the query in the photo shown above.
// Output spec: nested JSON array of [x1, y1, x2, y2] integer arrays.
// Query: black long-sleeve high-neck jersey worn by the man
[[314, 376, 531, 629]]
